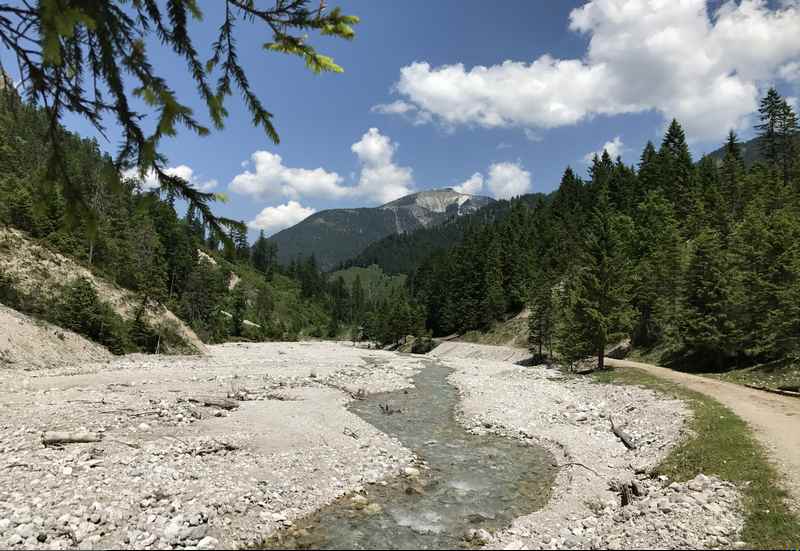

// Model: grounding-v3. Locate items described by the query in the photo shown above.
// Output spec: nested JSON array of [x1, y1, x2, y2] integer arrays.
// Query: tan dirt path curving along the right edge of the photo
[[606, 358, 800, 503]]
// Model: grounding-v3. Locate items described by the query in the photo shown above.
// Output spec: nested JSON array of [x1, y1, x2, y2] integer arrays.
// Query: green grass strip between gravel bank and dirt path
[[593, 368, 800, 549]]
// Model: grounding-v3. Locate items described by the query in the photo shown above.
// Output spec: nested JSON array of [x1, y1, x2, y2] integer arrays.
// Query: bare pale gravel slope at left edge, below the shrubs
[[0, 304, 112, 370]]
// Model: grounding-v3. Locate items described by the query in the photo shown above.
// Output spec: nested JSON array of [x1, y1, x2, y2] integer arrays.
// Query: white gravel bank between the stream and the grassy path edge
[[434, 345, 744, 549]]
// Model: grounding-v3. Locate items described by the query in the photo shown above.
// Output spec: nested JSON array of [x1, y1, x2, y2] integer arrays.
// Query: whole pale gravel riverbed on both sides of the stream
[[0, 342, 742, 549]]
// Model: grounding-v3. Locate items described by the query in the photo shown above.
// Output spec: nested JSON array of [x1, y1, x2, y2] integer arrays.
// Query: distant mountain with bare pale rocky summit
[[270, 188, 494, 270]]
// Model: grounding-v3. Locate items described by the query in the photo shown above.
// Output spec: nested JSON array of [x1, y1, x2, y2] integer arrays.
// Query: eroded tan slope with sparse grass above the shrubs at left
[[0, 227, 205, 352]]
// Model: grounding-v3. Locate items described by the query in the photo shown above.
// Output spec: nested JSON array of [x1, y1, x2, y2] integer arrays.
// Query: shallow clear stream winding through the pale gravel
[[265, 363, 555, 549]]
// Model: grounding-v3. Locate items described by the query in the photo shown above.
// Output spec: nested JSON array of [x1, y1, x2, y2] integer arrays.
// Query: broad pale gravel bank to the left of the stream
[[0, 343, 422, 549]]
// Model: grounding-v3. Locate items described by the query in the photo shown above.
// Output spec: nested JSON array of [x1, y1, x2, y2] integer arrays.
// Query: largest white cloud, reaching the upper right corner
[[378, 0, 800, 139]]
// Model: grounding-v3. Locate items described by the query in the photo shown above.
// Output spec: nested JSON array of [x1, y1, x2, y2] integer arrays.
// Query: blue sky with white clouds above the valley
[[4, 0, 800, 234]]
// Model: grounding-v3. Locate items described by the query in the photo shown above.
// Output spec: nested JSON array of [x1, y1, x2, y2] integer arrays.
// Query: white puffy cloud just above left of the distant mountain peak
[[230, 128, 413, 203]]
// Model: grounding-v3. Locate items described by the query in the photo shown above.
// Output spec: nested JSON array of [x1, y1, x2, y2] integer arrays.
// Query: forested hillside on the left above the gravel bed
[[0, 86, 424, 353]]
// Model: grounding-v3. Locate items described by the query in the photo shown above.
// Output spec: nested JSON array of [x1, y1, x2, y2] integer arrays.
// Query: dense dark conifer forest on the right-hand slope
[[410, 90, 800, 376]]
